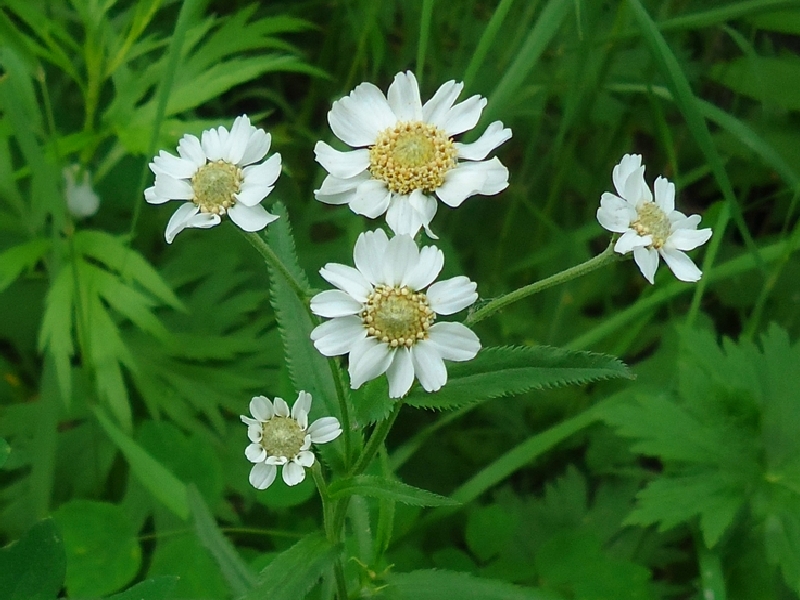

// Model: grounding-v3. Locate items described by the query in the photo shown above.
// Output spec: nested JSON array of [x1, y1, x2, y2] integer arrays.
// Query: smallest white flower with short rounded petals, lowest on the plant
[[239, 390, 342, 490]]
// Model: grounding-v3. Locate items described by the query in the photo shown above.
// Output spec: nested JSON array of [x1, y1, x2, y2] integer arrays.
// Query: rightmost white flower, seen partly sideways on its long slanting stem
[[597, 154, 711, 283]]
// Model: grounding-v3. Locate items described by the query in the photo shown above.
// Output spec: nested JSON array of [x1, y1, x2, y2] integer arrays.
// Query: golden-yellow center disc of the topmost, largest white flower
[[369, 121, 458, 194]]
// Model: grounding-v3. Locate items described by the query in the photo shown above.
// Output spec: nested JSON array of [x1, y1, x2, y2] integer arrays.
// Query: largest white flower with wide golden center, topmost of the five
[[314, 71, 511, 237]]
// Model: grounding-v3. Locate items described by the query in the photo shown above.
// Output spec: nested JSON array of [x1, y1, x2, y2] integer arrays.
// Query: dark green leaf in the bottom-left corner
[[0, 519, 67, 600]]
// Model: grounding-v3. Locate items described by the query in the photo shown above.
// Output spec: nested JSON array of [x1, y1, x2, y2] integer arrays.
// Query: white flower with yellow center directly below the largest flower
[[311, 229, 481, 398]]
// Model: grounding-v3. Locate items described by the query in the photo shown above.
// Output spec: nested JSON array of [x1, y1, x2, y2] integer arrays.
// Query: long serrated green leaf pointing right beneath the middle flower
[[406, 346, 633, 409]]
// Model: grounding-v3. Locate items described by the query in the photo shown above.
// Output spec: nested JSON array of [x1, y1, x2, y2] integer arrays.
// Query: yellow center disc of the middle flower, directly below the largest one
[[361, 285, 436, 348]]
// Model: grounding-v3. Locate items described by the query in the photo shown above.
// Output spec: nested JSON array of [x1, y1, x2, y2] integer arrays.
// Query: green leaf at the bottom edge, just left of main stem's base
[[245, 533, 338, 600]]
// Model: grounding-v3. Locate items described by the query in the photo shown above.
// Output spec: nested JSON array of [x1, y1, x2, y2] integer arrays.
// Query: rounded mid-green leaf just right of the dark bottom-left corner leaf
[[53, 500, 142, 596]]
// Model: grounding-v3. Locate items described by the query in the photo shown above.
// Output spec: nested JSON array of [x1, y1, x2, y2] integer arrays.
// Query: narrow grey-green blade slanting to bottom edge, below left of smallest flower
[[188, 484, 256, 597]]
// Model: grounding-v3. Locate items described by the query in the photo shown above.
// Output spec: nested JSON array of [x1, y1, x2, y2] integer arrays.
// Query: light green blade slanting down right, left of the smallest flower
[[94, 408, 189, 520]]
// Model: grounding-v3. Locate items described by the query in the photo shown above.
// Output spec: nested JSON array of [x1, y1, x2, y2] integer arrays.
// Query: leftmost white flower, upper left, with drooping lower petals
[[144, 115, 281, 244]]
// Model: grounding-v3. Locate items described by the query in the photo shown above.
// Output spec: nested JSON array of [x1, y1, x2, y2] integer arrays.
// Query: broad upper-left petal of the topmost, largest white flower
[[328, 83, 397, 148]]
